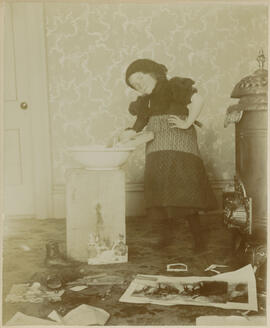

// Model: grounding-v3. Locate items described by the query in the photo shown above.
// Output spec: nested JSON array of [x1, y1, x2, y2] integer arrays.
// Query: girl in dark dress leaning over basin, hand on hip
[[120, 59, 216, 250]]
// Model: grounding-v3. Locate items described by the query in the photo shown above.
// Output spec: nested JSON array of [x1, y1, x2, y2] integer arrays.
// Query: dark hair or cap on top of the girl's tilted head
[[126, 58, 168, 89]]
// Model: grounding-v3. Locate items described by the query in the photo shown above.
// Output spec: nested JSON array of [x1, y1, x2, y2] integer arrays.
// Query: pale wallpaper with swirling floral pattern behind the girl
[[45, 2, 268, 185]]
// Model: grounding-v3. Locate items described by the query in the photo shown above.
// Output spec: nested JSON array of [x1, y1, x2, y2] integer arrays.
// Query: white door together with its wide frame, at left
[[4, 2, 53, 219]]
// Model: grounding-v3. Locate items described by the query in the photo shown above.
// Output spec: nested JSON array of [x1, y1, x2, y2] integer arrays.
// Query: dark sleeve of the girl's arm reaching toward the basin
[[128, 95, 149, 132]]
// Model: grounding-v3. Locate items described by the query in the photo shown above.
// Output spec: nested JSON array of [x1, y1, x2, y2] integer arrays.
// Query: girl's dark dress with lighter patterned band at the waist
[[129, 77, 216, 217]]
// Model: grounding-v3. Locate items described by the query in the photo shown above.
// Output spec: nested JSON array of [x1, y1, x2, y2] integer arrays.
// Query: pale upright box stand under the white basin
[[66, 169, 127, 264]]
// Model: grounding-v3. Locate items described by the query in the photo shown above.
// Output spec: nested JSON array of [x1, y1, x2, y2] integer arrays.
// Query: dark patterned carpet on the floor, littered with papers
[[3, 215, 264, 326]]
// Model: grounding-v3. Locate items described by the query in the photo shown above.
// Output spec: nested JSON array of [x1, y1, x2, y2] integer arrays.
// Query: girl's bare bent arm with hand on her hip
[[168, 93, 203, 129]]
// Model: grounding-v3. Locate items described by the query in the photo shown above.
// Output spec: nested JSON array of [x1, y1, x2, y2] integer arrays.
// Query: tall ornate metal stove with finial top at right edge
[[223, 50, 268, 272]]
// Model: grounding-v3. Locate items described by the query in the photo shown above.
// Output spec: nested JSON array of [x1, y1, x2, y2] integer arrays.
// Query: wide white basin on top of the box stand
[[69, 146, 135, 170]]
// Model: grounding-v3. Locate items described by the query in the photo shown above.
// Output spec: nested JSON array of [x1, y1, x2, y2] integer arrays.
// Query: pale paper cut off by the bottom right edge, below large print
[[196, 315, 266, 327]]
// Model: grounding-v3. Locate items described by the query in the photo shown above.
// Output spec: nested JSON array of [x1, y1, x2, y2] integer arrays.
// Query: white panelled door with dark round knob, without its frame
[[4, 3, 35, 217]]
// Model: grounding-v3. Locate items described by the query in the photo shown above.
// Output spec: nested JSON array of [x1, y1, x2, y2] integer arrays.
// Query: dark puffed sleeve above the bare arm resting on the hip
[[169, 77, 197, 106]]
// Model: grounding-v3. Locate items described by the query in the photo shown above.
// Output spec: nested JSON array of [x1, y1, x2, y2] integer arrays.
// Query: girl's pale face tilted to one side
[[129, 72, 157, 95]]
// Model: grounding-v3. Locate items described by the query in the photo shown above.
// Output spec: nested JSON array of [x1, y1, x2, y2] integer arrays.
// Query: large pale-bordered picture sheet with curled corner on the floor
[[120, 265, 258, 311]]
